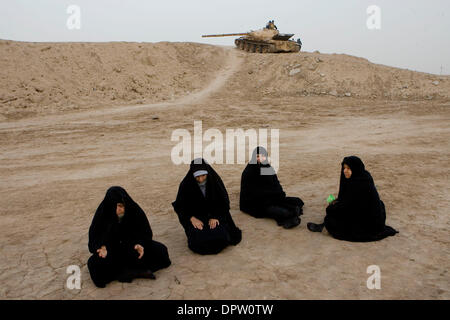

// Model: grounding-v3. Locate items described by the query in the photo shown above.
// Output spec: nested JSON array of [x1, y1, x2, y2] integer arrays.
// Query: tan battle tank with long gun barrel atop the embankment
[[202, 20, 302, 53]]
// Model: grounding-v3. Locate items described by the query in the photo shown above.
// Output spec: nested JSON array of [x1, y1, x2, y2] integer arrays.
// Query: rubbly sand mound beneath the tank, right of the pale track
[[225, 52, 450, 100]]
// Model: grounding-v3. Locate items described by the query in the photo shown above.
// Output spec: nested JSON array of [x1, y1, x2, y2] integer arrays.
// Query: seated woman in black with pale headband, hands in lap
[[172, 158, 242, 254]]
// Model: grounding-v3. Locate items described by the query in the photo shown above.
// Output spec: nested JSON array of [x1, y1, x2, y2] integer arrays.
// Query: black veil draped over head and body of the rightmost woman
[[328, 156, 397, 240]]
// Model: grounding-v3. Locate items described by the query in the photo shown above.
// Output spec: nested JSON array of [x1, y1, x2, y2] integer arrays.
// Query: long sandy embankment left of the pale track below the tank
[[0, 41, 224, 117]]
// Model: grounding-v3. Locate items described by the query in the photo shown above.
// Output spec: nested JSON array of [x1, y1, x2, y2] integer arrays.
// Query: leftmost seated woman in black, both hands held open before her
[[88, 187, 171, 288]]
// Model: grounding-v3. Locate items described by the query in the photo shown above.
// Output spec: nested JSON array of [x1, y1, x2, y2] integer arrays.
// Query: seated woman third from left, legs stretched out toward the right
[[239, 147, 303, 229]]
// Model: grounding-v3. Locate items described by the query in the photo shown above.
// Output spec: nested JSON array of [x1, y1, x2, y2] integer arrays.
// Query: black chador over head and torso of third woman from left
[[239, 146, 286, 214]]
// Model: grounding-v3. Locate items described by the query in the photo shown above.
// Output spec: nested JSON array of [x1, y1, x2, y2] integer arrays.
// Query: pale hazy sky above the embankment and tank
[[0, 0, 450, 74]]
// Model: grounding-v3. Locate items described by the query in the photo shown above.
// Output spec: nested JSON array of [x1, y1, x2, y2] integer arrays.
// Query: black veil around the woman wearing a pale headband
[[172, 158, 241, 244]]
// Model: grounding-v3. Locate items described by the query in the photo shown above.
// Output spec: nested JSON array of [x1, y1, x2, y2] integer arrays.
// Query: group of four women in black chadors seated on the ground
[[88, 147, 398, 287]]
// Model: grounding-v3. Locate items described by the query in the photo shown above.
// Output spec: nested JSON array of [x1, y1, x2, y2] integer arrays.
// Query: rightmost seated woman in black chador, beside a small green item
[[308, 156, 398, 242]]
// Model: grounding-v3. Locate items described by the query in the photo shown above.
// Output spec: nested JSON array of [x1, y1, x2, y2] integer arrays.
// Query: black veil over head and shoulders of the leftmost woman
[[88, 186, 153, 253]]
